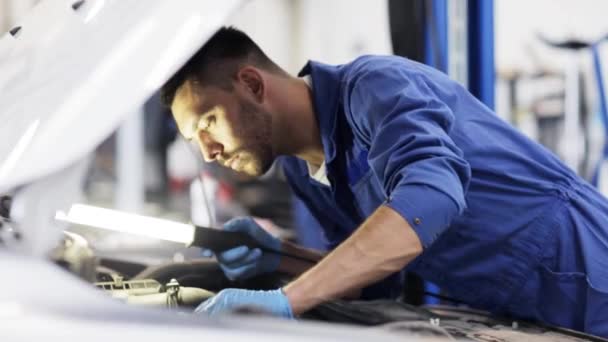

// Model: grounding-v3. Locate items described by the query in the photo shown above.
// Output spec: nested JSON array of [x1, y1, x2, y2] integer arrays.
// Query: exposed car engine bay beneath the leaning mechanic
[[40, 224, 605, 342]]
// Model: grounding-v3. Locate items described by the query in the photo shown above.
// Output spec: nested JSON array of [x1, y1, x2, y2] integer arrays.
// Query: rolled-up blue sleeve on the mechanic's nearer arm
[[346, 67, 471, 248]]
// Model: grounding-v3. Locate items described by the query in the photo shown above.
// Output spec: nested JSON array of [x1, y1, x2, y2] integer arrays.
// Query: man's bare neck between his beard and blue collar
[[274, 77, 325, 166]]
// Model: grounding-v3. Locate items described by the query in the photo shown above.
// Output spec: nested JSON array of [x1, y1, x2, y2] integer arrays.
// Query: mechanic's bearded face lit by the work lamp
[[171, 81, 274, 176]]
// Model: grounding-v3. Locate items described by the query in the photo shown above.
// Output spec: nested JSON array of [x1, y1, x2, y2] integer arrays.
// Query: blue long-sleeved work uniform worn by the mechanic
[[282, 56, 608, 335]]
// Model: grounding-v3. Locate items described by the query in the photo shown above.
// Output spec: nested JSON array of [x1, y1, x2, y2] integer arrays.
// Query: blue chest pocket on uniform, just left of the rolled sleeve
[[347, 150, 386, 219]]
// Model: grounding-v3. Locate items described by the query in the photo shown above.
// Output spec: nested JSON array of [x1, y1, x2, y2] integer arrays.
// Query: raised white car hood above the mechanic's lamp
[[0, 0, 241, 194]]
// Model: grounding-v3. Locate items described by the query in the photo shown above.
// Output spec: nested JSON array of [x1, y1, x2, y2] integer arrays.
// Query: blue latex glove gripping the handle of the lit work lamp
[[203, 217, 282, 280]]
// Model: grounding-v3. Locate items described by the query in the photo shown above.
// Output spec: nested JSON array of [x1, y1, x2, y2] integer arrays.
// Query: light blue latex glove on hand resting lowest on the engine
[[194, 289, 293, 318]]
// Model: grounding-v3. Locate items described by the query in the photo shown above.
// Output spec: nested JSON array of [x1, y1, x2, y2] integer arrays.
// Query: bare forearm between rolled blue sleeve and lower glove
[[283, 206, 422, 314]]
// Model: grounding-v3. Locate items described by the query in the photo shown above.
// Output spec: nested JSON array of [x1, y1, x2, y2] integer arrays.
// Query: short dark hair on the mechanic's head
[[161, 27, 284, 107]]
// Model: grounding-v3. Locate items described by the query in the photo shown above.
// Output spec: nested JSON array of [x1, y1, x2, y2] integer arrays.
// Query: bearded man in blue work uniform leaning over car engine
[[163, 28, 608, 336]]
